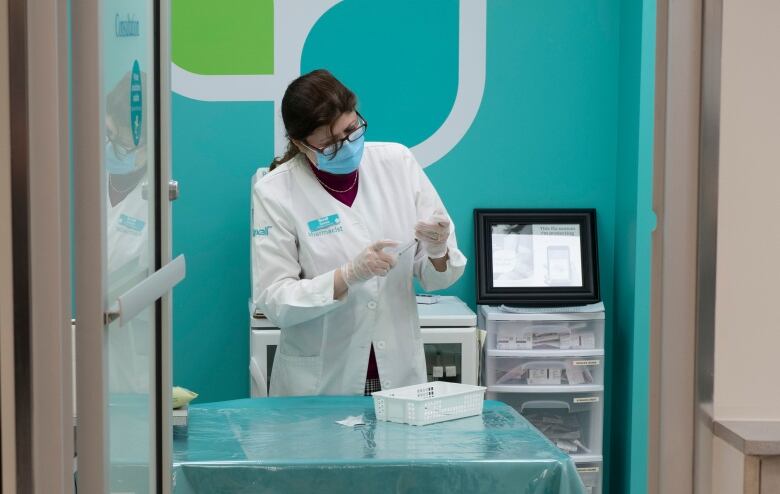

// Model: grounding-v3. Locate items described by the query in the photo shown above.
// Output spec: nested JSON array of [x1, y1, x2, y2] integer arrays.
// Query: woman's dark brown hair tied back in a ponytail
[[271, 69, 357, 170]]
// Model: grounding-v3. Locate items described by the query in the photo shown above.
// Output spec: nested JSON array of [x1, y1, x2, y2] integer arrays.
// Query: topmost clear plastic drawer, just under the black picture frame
[[479, 306, 604, 351]]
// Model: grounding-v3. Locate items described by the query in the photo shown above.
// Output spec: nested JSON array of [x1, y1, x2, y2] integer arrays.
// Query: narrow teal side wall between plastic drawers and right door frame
[[609, 0, 655, 493]]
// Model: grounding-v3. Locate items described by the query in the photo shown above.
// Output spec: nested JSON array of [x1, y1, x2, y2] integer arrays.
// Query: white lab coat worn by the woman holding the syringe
[[252, 143, 466, 396]]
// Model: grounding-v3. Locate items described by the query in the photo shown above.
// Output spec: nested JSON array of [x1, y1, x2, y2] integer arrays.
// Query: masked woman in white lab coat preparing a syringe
[[252, 70, 466, 396]]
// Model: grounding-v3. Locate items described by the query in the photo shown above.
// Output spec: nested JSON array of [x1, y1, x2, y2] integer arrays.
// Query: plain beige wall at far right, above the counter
[[714, 0, 780, 420]]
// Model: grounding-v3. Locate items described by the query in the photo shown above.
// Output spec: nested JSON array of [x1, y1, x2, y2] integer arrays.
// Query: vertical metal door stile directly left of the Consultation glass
[[71, 0, 109, 493]]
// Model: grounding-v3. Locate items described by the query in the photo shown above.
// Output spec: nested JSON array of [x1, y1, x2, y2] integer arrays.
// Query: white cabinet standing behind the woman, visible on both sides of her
[[249, 296, 479, 397]]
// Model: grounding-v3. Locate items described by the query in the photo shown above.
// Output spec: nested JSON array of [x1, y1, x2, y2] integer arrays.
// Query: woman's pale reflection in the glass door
[[103, 72, 154, 394]]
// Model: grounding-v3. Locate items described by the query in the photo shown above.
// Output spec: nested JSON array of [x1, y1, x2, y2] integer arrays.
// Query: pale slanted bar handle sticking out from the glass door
[[103, 254, 187, 326]]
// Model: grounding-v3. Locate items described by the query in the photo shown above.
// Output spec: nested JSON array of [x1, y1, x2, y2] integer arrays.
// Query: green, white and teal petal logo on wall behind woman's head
[[171, 0, 487, 166]]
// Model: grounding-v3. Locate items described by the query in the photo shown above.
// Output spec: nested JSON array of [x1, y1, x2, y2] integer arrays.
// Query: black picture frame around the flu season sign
[[474, 209, 601, 307]]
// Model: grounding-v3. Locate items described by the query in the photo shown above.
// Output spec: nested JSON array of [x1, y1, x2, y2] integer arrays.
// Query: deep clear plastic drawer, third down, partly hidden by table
[[487, 390, 604, 461]]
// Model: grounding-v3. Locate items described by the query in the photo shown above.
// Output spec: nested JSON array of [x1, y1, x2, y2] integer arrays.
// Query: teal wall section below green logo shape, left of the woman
[[172, 94, 273, 401]]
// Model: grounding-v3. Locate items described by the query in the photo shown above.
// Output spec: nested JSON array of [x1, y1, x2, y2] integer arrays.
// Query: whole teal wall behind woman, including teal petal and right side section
[[173, 0, 655, 493]]
